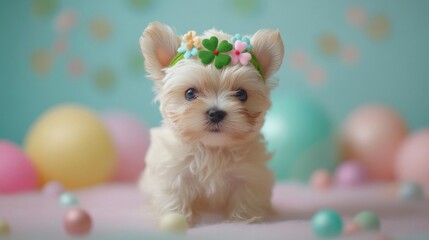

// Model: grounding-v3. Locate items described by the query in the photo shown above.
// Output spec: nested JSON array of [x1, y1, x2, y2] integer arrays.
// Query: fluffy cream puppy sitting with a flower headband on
[[139, 22, 284, 224]]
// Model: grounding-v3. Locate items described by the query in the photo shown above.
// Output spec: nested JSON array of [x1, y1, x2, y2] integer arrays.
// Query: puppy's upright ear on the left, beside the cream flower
[[140, 22, 180, 84]]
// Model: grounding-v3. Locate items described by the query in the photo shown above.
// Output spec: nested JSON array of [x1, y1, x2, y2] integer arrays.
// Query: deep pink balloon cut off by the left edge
[[0, 140, 38, 194]]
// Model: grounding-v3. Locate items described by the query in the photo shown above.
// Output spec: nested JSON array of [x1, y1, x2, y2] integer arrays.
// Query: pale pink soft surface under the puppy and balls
[[0, 183, 429, 240]]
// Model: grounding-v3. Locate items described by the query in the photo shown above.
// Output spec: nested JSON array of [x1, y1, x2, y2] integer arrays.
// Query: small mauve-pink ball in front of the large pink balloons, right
[[335, 161, 368, 187]]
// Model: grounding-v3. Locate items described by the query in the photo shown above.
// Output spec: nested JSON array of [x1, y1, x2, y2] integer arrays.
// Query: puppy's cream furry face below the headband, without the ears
[[158, 59, 270, 146]]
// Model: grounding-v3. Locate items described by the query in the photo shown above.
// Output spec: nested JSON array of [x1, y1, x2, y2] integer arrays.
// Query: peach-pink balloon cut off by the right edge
[[396, 129, 429, 187]]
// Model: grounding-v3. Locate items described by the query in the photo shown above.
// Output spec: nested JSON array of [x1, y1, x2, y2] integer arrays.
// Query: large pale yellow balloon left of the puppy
[[25, 105, 116, 189]]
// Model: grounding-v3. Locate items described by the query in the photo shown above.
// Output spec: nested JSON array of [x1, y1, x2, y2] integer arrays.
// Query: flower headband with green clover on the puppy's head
[[168, 31, 264, 79]]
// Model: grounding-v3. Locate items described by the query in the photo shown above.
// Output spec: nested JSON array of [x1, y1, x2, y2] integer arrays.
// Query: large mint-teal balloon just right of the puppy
[[262, 95, 339, 182]]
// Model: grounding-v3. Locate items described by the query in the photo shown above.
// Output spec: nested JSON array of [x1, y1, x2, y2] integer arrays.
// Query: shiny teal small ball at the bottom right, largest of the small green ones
[[311, 209, 343, 237]]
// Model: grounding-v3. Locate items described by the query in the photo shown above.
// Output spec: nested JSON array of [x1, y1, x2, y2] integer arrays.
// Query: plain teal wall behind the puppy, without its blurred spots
[[0, 0, 429, 143]]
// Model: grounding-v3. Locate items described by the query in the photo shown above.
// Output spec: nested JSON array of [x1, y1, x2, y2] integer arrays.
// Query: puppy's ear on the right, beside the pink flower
[[251, 29, 284, 79]]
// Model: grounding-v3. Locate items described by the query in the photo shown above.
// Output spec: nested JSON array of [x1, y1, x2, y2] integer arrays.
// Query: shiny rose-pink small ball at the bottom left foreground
[[64, 208, 92, 236]]
